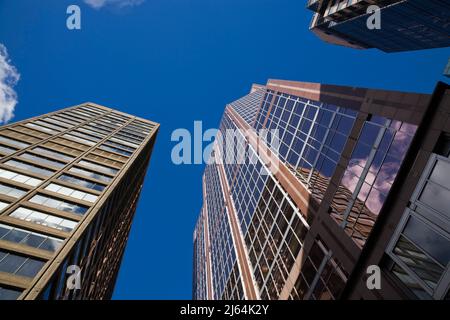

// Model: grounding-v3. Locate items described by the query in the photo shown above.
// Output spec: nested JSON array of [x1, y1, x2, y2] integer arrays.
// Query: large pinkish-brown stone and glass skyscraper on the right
[[193, 80, 450, 299]]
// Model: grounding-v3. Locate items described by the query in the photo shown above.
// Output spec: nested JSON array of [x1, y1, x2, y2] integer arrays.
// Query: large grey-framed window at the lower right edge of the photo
[[386, 153, 450, 299]]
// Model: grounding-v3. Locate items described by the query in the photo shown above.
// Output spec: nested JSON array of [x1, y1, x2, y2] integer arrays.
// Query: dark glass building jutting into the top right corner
[[307, 0, 450, 52]]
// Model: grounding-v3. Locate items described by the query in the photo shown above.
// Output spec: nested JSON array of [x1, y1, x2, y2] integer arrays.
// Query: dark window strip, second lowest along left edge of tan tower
[[0, 250, 45, 278]]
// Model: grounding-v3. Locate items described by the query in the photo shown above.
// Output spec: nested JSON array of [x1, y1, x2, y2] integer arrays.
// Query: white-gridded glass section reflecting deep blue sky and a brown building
[[257, 94, 356, 202]]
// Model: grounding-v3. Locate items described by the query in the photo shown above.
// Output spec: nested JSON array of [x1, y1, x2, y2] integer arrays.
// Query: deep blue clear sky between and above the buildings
[[0, 0, 450, 299]]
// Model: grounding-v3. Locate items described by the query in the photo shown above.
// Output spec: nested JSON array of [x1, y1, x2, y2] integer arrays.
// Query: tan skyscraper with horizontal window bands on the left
[[0, 103, 159, 299]]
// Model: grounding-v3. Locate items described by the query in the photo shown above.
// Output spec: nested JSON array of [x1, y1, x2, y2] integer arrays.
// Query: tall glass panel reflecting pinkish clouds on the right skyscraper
[[331, 116, 416, 247]]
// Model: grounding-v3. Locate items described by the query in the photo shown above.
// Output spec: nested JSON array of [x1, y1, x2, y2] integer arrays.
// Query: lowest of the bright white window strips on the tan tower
[[9, 207, 77, 232]]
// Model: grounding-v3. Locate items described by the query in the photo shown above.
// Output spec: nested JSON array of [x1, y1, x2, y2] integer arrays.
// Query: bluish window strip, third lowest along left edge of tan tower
[[0, 224, 62, 252]]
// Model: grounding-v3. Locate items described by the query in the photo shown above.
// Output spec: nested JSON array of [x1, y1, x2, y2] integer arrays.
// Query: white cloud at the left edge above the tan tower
[[0, 43, 20, 123]]
